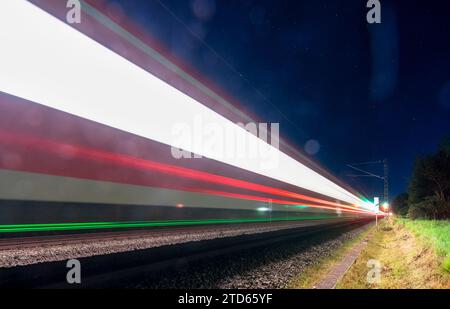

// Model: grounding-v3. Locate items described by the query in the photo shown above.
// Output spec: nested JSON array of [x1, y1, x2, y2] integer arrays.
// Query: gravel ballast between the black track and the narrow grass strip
[[133, 220, 371, 289]]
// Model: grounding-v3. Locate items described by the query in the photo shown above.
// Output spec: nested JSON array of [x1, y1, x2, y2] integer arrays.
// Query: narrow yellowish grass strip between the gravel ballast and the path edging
[[286, 226, 375, 289]]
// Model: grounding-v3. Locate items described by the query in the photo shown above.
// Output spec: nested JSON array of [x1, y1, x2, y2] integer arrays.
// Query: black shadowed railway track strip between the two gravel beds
[[0, 220, 372, 288]]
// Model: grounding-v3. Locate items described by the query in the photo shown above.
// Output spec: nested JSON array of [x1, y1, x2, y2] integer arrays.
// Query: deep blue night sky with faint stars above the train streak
[[106, 0, 450, 197]]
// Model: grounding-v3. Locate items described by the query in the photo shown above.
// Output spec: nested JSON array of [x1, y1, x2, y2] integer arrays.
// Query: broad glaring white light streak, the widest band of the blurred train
[[0, 1, 374, 207]]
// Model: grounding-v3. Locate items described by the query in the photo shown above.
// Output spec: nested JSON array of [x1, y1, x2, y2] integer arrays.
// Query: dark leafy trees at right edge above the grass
[[392, 138, 450, 219]]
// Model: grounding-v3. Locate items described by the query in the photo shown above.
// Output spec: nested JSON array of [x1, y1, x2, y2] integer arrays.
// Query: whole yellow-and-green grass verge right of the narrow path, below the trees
[[337, 219, 450, 289]]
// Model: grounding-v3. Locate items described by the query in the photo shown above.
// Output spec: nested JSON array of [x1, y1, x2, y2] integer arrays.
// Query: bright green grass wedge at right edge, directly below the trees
[[397, 219, 450, 272]]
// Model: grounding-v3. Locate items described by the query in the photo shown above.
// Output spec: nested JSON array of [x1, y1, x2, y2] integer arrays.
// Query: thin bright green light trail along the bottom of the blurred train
[[0, 216, 337, 233]]
